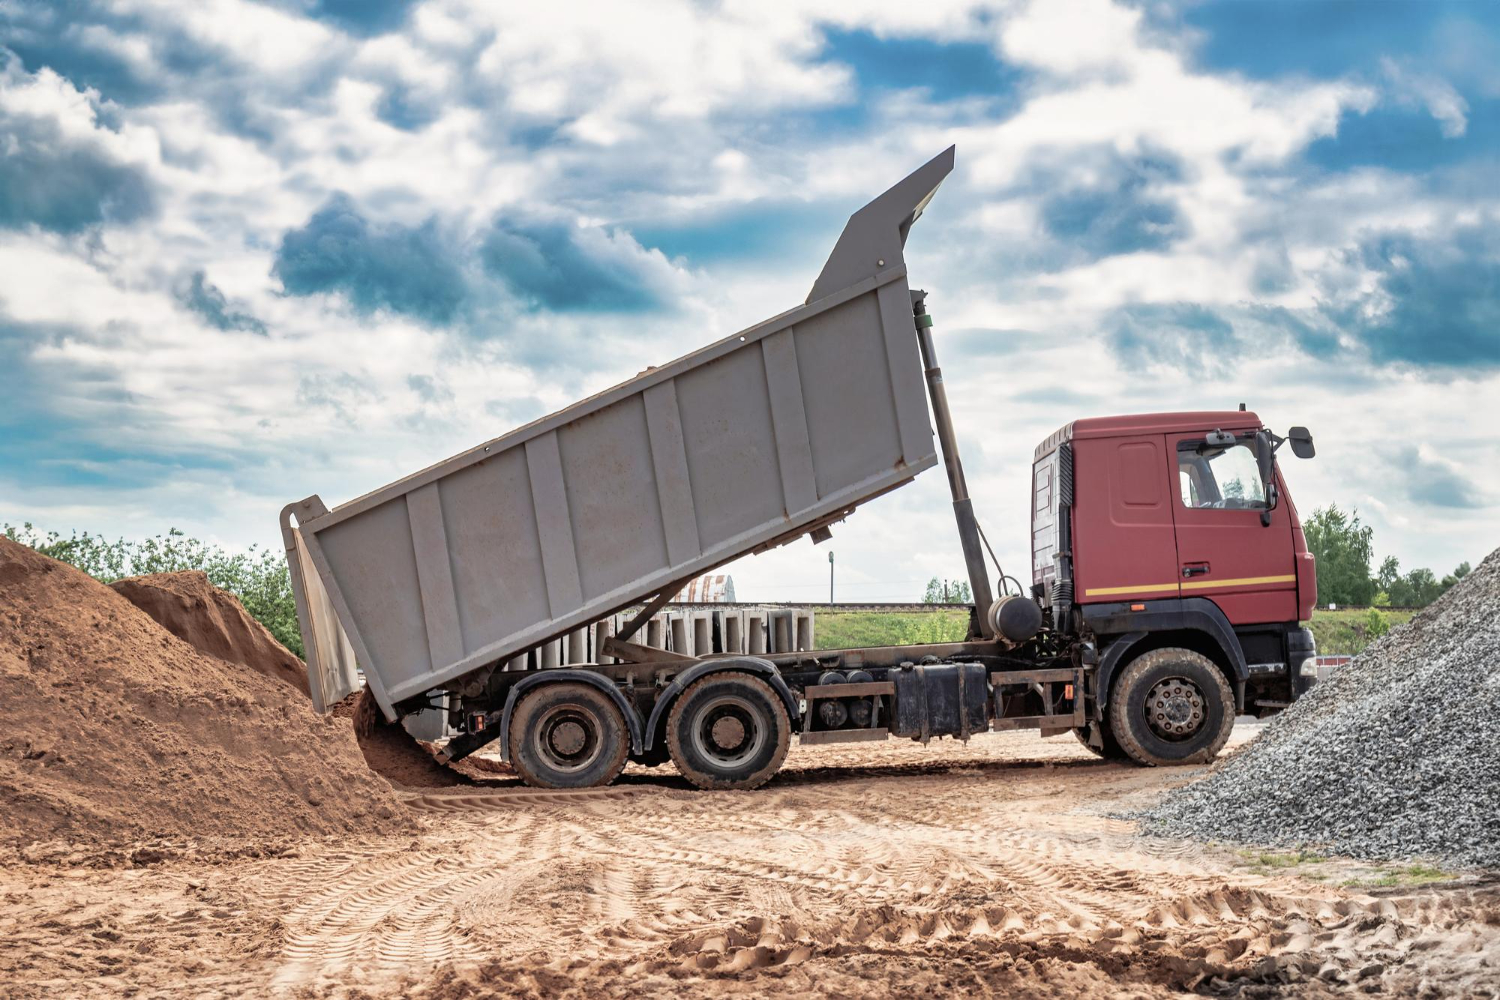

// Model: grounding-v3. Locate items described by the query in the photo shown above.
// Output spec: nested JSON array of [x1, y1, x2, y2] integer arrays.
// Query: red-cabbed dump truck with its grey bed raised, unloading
[[281, 147, 1317, 789]]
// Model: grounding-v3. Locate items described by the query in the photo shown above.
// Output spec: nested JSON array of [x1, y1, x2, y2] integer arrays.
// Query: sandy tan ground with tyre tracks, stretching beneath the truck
[[0, 727, 1500, 1000]]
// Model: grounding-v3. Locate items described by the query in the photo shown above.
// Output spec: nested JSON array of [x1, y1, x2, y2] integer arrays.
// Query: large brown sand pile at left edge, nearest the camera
[[0, 538, 411, 844]]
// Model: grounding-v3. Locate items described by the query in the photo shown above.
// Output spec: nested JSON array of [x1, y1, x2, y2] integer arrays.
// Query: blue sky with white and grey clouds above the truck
[[0, 0, 1500, 601]]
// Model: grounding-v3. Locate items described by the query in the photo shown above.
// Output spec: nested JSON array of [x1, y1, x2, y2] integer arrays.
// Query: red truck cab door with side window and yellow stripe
[[1167, 432, 1298, 625]]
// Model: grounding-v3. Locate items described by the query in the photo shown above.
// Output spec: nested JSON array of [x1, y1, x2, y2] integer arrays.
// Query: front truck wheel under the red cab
[[1109, 648, 1235, 768]]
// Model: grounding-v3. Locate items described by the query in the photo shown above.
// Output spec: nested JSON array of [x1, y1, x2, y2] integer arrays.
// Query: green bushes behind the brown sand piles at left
[[3, 523, 303, 657]]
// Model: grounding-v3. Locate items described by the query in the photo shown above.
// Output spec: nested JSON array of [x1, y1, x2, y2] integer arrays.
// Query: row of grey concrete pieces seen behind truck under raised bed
[[402, 604, 813, 742]]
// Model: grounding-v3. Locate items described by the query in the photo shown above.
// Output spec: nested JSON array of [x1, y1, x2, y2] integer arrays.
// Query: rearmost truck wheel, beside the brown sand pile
[[510, 682, 630, 789]]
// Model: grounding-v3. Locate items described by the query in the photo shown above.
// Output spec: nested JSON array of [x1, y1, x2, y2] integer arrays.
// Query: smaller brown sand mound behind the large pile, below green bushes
[[110, 570, 308, 694]]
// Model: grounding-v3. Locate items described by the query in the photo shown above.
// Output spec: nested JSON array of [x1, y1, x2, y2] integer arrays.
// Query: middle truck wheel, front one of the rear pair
[[666, 670, 792, 789]]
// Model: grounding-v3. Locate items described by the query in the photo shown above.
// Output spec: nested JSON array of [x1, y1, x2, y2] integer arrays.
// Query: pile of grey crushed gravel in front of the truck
[[1137, 552, 1500, 867]]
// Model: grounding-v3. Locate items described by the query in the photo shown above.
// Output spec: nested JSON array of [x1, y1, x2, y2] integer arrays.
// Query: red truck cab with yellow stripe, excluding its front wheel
[[1032, 409, 1317, 761]]
